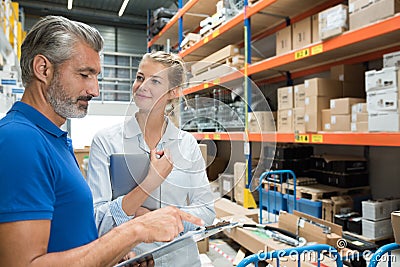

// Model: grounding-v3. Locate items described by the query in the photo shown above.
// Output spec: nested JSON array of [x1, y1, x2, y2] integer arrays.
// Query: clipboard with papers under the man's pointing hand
[[114, 221, 238, 267]]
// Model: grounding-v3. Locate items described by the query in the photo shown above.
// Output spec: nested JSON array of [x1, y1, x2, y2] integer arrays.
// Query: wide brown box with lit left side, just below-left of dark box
[[304, 78, 342, 98]]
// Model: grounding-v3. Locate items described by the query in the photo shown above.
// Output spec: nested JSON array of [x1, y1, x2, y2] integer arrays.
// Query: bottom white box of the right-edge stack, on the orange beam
[[368, 112, 400, 132]]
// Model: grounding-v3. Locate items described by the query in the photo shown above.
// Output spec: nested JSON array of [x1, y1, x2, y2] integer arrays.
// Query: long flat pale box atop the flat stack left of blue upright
[[191, 45, 240, 75]]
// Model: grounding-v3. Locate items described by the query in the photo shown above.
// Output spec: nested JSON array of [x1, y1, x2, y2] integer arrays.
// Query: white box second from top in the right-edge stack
[[365, 67, 400, 92]]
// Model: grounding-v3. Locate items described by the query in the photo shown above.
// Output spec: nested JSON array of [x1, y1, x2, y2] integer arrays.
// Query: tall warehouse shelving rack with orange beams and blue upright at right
[[148, 0, 400, 209]]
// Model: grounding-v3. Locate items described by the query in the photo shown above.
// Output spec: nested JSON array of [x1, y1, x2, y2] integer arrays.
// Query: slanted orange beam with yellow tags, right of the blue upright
[[248, 16, 400, 75]]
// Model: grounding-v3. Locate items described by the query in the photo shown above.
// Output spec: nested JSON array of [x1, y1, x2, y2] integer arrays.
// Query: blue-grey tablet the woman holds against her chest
[[110, 153, 161, 210]]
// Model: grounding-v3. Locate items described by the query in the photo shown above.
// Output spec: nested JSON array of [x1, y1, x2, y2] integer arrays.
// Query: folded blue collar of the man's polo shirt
[[8, 101, 67, 137]]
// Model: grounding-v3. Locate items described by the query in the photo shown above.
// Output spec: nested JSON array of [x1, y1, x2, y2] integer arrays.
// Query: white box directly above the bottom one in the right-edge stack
[[367, 89, 399, 113]]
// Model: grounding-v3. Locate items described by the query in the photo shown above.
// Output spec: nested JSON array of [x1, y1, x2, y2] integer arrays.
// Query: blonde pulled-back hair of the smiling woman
[[139, 51, 186, 90]]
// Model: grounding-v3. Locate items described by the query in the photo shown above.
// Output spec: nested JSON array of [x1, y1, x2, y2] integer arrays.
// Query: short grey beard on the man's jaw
[[46, 73, 87, 119]]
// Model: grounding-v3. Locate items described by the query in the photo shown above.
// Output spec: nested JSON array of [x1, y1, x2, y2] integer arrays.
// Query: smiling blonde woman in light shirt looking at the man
[[87, 51, 215, 266]]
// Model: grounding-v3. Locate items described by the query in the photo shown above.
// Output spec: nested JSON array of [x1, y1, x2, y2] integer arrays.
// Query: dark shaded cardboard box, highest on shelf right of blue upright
[[331, 64, 365, 82]]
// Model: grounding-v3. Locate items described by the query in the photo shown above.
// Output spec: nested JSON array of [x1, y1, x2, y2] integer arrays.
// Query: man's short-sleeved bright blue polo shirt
[[0, 102, 98, 252]]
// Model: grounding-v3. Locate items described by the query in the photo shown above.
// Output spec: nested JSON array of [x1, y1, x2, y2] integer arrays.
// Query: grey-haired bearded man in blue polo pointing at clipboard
[[0, 16, 203, 267]]
